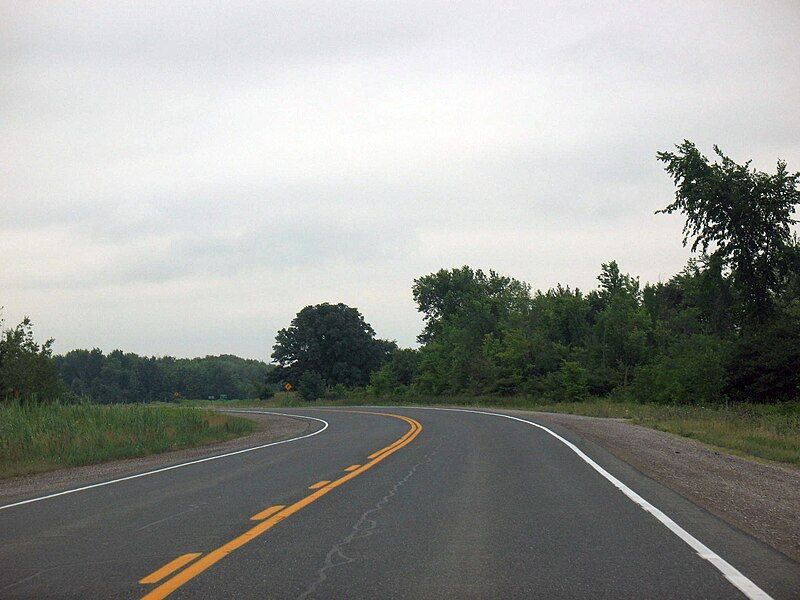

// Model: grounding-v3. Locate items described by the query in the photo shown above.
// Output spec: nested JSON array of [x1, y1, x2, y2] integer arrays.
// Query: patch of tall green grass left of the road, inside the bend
[[0, 403, 255, 478]]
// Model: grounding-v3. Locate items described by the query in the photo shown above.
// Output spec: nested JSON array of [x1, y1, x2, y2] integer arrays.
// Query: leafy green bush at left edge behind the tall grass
[[0, 317, 65, 402]]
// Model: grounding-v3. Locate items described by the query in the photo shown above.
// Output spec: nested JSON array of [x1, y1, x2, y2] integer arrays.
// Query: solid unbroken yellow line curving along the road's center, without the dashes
[[142, 411, 422, 600]]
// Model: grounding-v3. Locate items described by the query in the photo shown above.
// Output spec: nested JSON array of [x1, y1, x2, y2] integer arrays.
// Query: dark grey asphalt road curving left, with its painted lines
[[0, 408, 800, 599]]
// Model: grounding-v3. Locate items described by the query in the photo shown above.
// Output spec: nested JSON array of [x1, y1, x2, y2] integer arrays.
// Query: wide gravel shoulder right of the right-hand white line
[[507, 411, 800, 562]]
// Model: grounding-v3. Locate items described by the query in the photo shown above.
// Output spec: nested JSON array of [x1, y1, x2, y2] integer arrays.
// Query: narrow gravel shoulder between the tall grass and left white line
[[0, 413, 314, 505]]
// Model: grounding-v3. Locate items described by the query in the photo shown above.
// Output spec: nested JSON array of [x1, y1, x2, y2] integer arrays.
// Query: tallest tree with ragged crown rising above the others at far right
[[657, 140, 800, 324]]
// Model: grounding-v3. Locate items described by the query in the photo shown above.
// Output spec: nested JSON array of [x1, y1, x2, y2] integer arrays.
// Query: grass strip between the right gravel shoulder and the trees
[[194, 393, 800, 466]]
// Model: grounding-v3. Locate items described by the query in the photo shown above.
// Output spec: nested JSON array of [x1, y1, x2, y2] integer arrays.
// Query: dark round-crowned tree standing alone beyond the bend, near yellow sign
[[272, 303, 396, 387]]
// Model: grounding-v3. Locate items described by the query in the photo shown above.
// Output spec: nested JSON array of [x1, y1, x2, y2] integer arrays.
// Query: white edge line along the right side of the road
[[370, 406, 773, 600]]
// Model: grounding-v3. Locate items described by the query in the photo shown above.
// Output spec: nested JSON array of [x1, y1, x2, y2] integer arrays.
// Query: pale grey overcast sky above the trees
[[0, 0, 800, 359]]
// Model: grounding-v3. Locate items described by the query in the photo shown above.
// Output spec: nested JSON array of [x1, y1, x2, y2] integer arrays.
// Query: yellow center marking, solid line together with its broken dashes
[[140, 411, 422, 600]]
